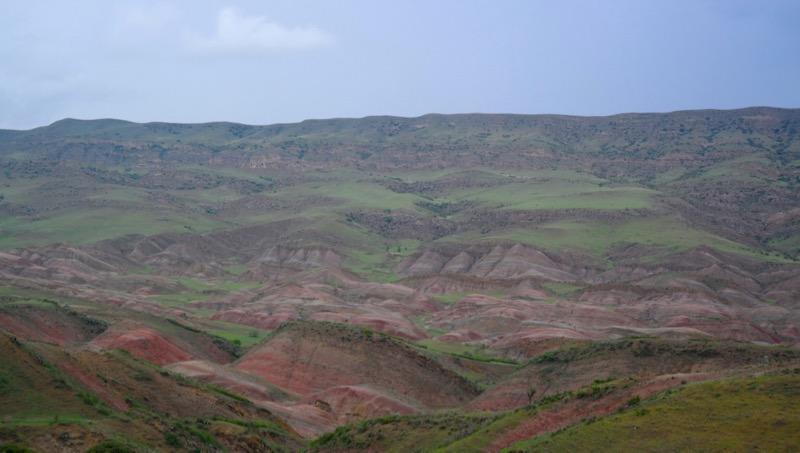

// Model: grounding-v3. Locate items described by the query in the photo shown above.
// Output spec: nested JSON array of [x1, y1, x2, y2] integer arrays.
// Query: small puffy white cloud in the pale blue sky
[[187, 8, 334, 53]]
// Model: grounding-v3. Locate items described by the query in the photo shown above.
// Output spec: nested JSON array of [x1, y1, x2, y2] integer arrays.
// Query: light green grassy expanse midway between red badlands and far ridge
[[0, 166, 791, 266]]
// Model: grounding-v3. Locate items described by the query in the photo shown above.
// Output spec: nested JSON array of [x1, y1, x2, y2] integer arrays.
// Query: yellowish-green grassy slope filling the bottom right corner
[[508, 374, 800, 452]]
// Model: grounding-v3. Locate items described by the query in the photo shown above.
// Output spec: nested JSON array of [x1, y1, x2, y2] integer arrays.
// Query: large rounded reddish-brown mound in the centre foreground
[[236, 322, 477, 408]]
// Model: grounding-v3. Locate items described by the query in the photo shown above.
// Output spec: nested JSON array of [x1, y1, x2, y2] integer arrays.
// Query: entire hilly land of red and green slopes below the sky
[[0, 107, 800, 451]]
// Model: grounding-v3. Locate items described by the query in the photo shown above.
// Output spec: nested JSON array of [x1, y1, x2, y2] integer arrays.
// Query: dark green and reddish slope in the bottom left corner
[[0, 335, 299, 451]]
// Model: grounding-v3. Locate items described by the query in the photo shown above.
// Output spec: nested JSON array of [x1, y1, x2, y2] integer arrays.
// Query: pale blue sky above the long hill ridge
[[0, 0, 800, 129]]
